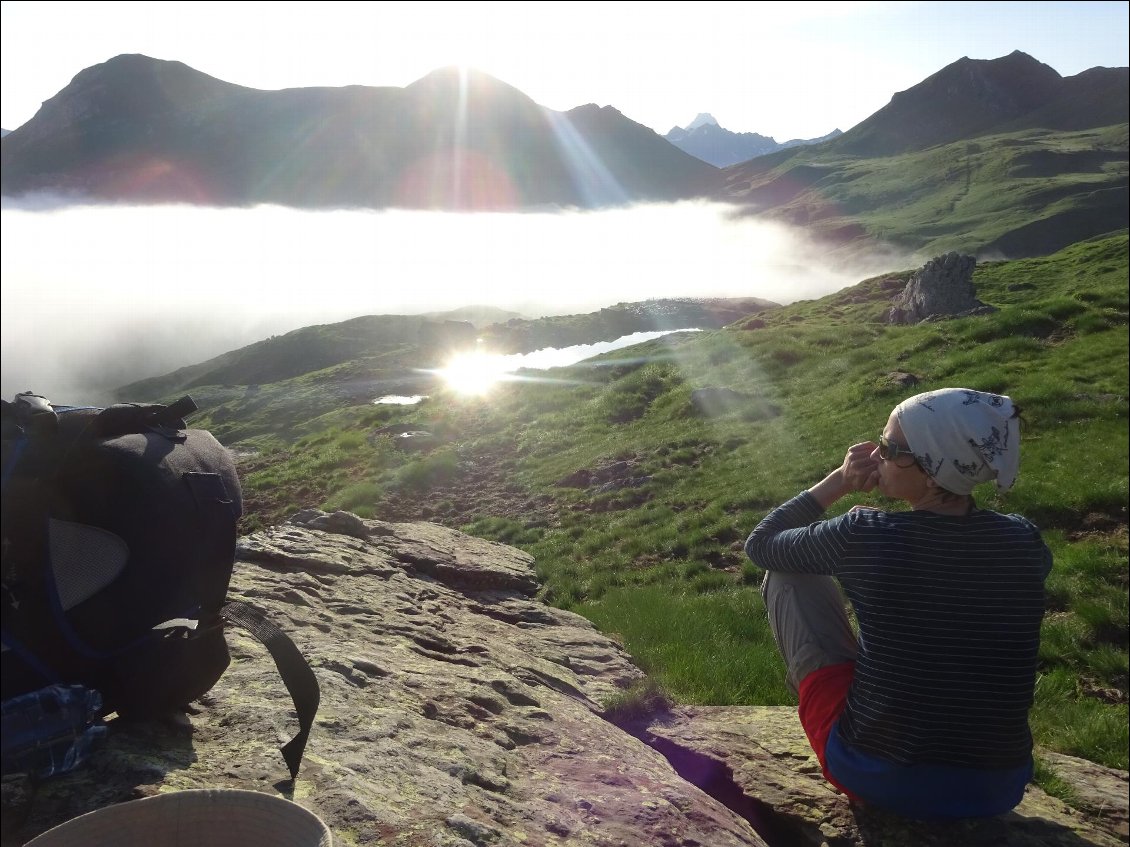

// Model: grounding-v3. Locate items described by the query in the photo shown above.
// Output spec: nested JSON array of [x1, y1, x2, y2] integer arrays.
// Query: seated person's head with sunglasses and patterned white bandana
[[876, 388, 1020, 503]]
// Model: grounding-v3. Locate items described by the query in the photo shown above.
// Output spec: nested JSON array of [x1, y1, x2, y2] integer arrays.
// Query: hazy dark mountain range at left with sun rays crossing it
[[0, 54, 718, 209]]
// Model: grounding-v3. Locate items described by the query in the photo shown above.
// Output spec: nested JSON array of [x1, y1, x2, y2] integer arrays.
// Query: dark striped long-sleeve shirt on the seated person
[[746, 492, 1052, 769]]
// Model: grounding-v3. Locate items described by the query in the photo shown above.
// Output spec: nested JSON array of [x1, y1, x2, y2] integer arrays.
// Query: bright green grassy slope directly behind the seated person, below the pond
[[194, 233, 1128, 781]]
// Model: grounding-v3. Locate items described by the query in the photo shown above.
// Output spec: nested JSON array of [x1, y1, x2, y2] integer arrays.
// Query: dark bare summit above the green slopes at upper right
[[827, 50, 1130, 156]]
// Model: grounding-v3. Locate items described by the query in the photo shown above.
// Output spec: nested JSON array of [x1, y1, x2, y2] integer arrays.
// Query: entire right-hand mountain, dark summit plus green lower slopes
[[719, 52, 1130, 257]]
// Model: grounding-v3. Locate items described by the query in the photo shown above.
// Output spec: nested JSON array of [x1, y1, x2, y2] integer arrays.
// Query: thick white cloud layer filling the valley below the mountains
[[0, 202, 913, 403]]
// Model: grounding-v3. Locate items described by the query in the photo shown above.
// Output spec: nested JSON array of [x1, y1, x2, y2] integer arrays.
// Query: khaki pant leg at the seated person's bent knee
[[762, 570, 859, 692]]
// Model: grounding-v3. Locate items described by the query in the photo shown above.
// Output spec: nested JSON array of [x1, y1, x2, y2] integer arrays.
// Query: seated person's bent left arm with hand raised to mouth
[[745, 443, 878, 574]]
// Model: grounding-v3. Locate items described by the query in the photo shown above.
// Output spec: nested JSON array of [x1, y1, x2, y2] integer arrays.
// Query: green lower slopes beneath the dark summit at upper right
[[724, 123, 1130, 257]]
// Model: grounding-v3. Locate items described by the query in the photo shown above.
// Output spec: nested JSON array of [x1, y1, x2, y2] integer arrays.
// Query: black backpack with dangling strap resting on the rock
[[0, 392, 320, 779]]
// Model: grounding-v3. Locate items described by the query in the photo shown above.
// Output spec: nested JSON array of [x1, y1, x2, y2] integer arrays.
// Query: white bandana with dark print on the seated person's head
[[895, 388, 1020, 495]]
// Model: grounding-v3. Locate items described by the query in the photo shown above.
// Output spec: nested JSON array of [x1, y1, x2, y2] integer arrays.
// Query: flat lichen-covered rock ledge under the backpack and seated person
[[2, 510, 1128, 847]]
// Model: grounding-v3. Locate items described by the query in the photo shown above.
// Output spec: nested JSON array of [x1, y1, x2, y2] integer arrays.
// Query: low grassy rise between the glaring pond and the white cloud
[[123, 297, 777, 406]]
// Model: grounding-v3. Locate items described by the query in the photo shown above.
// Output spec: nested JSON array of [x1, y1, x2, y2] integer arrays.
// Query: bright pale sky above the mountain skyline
[[0, 0, 1130, 141]]
